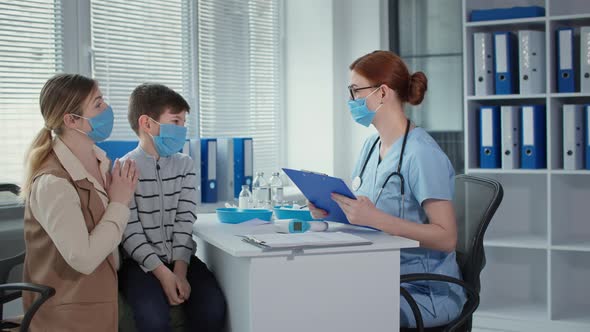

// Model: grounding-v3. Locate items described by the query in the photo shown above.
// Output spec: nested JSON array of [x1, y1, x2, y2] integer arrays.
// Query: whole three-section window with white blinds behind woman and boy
[[0, 0, 283, 183]]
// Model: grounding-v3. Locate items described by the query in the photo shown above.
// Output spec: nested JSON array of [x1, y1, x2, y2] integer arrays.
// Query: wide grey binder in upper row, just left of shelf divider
[[518, 30, 547, 95]]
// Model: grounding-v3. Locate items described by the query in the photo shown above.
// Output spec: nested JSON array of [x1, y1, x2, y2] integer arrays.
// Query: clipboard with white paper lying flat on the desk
[[245, 232, 371, 248]]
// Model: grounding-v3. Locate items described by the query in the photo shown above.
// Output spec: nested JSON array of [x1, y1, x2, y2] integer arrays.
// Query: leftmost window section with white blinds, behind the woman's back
[[0, 0, 63, 183]]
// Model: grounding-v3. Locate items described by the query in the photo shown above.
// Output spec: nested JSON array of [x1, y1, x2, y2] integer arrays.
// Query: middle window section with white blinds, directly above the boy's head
[[91, 0, 198, 140]]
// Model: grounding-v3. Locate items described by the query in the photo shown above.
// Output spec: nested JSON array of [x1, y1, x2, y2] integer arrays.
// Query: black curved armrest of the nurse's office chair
[[400, 273, 479, 331]]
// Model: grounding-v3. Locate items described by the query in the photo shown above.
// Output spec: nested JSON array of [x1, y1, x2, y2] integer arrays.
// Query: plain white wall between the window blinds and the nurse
[[285, 0, 388, 180]]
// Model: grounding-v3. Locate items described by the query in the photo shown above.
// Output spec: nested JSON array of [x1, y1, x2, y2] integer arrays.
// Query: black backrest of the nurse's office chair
[[453, 175, 504, 292]]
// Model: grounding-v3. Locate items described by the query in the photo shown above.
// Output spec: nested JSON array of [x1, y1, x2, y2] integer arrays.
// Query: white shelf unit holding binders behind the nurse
[[462, 0, 590, 331]]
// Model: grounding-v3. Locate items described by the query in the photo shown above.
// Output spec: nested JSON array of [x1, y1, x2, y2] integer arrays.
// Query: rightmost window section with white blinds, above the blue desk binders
[[197, 0, 282, 177]]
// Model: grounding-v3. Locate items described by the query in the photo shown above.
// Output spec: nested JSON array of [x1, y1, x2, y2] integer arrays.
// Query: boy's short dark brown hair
[[127, 83, 190, 135]]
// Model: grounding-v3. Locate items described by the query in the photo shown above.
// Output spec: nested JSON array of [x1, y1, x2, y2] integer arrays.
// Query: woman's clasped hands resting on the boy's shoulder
[[108, 159, 139, 206]]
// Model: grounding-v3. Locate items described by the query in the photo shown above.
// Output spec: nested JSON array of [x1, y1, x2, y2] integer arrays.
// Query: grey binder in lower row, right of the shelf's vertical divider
[[563, 104, 585, 169]]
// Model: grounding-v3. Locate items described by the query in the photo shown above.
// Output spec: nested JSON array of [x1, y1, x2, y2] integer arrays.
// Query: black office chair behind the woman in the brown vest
[[0, 183, 55, 332]]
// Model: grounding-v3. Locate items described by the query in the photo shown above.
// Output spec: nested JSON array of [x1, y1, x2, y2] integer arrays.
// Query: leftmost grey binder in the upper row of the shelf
[[473, 32, 494, 96]]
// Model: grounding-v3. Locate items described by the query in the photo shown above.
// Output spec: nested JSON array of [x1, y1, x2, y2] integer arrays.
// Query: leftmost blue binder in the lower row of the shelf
[[479, 106, 502, 168]]
